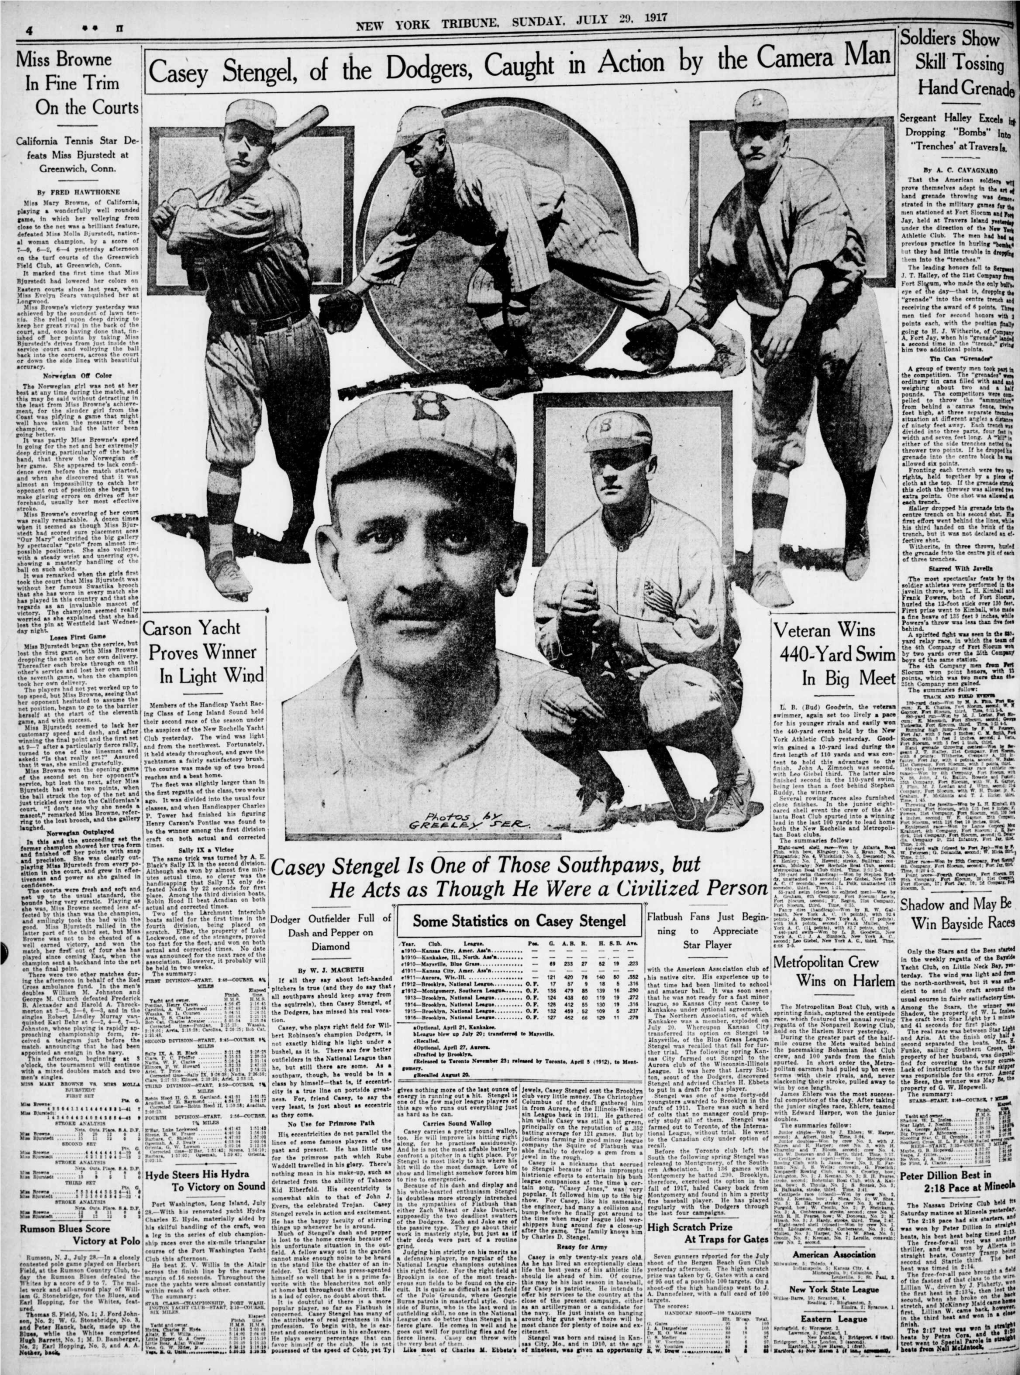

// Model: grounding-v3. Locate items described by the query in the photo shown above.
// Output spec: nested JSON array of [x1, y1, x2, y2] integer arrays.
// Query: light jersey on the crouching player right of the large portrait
[[535, 498, 740, 683]]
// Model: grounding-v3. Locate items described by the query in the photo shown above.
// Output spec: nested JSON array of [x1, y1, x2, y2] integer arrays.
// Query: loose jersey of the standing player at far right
[[678, 157, 866, 325]]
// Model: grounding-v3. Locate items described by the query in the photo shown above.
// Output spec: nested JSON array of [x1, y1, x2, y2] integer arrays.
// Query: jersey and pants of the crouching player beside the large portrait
[[535, 498, 744, 749]]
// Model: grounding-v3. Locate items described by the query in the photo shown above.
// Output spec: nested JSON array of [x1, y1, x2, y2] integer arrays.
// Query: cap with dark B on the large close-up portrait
[[326, 391, 517, 492]]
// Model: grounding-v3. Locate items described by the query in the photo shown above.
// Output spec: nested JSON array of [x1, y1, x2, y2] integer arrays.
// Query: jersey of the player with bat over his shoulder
[[166, 166, 309, 320]]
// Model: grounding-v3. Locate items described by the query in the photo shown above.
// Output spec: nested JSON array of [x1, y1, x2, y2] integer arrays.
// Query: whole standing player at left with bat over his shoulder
[[153, 99, 330, 601]]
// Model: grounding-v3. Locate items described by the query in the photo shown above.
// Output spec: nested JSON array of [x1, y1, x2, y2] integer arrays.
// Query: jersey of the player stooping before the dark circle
[[359, 143, 564, 293]]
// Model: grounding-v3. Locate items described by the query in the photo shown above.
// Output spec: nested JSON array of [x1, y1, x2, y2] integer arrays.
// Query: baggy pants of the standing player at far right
[[751, 286, 892, 476]]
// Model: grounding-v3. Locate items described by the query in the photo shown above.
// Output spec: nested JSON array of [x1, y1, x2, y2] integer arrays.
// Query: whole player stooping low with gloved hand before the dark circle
[[319, 105, 744, 400]]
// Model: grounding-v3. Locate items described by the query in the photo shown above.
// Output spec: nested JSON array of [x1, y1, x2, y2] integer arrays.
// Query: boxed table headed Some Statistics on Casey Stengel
[[395, 902, 645, 1084]]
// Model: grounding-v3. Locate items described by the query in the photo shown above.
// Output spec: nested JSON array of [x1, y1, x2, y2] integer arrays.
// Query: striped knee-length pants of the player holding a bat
[[205, 315, 330, 473]]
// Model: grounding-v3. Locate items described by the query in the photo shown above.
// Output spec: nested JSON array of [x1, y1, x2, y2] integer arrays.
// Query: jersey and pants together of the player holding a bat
[[166, 166, 330, 473]]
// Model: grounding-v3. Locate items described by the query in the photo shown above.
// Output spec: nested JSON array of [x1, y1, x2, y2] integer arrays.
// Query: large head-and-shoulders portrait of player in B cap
[[283, 391, 632, 840]]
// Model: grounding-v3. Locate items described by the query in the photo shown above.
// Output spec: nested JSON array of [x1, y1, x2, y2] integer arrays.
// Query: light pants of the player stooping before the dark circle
[[467, 186, 669, 319]]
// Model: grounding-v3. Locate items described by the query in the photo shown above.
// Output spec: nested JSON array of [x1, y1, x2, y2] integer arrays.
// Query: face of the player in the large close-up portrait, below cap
[[318, 476, 526, 681]]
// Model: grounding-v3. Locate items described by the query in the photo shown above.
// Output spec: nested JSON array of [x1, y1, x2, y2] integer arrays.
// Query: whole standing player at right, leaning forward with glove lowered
[[635, 89, 892, 609]]
